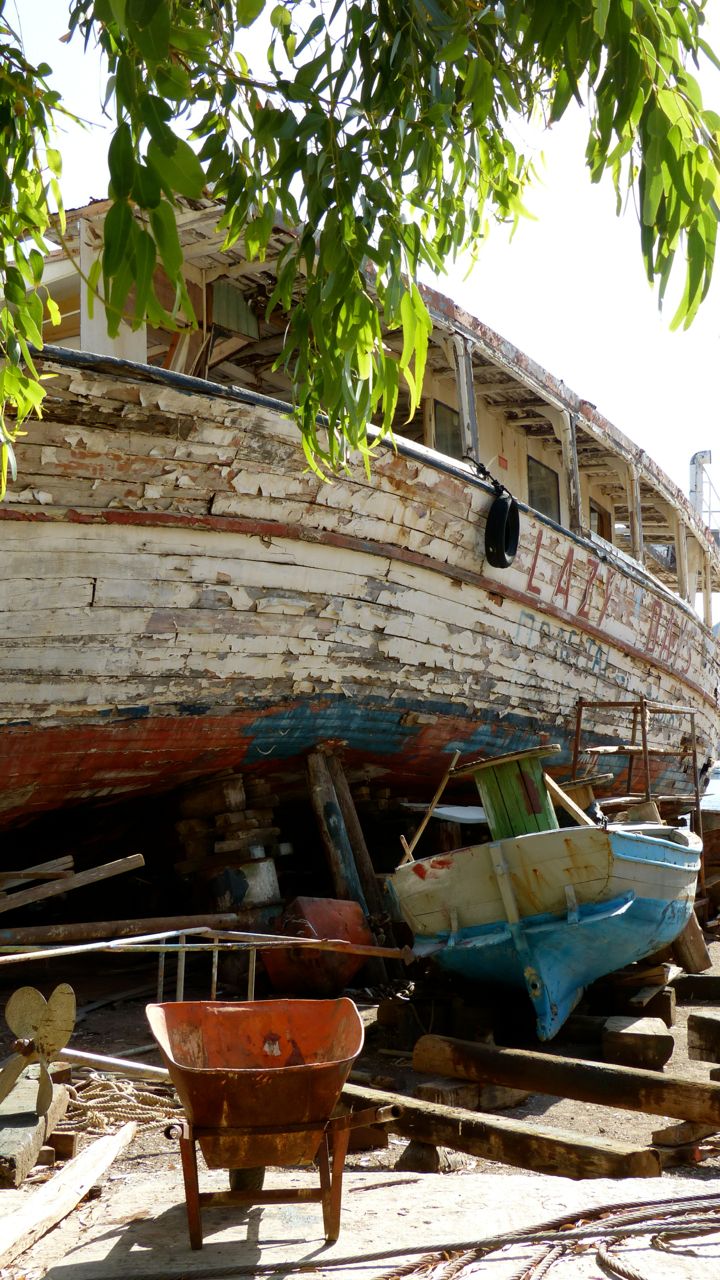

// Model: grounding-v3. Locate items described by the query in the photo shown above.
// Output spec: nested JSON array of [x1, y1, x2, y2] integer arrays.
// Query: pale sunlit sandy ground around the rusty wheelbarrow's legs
[[0, 943, 720, 1280]]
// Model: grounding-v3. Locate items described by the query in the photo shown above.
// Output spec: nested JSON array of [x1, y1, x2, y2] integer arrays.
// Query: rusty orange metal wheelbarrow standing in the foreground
[[146, 998, 398, 1249]]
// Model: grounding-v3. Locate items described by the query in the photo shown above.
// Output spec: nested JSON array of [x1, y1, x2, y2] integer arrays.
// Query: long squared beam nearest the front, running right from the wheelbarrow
[[342, 1084, 661, 1178]]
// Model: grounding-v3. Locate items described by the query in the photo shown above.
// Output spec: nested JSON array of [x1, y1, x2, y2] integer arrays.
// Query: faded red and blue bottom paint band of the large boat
[[0, 695, 670, 827]]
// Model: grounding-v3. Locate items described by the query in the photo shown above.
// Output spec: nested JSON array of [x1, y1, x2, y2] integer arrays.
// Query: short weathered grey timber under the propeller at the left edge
[[0, 1066, 68, 1187]]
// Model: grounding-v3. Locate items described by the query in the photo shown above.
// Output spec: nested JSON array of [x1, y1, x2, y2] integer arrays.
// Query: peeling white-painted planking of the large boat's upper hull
[[0, 360, 716, 824]]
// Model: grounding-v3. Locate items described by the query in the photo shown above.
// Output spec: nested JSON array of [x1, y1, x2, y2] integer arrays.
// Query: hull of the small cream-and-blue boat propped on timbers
[[389, 827, 700, 1039]]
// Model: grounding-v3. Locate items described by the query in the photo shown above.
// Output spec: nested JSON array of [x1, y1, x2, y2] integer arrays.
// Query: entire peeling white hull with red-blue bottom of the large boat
[[0, 356, 720, 823]]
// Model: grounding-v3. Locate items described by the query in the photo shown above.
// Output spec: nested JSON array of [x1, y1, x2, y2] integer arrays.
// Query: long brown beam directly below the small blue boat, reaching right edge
[[413, 1036, 720, 1124]]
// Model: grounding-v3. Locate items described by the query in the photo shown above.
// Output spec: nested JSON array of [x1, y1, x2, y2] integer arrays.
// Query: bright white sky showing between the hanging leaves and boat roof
[[14, 0, 720, 524]]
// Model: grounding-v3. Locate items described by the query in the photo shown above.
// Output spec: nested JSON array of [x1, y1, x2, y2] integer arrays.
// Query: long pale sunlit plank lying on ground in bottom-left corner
[[0, 1121, 136, 1267]]
